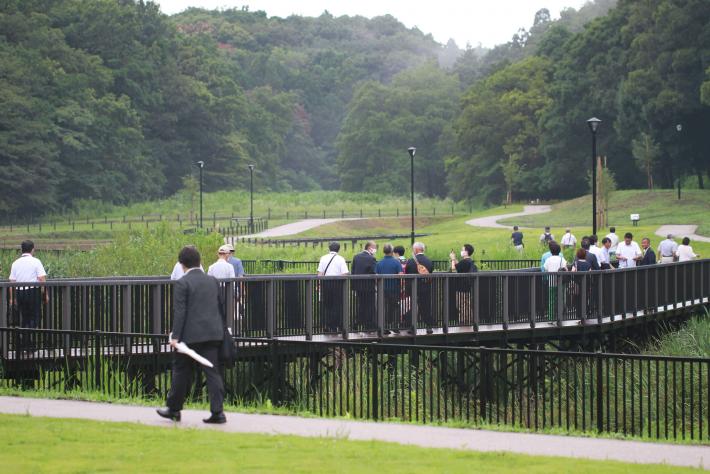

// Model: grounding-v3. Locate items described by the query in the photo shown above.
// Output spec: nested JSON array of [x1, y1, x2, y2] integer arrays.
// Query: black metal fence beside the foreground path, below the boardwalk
[[0, 328, 710, 441]]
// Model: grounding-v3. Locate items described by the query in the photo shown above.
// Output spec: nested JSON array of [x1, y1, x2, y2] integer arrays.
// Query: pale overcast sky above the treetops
[[156, 0, 586, 48]]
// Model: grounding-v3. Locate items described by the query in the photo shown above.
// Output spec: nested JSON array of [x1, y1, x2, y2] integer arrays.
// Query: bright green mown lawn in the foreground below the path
[[0, 415, 697, 474]]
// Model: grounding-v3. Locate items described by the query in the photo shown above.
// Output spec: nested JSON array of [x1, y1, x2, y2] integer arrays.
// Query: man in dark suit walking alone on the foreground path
[[158, 246, 227, 423]]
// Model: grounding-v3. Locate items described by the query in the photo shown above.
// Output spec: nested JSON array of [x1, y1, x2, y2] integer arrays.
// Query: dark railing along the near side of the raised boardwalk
[[0, 260, 710, 339]]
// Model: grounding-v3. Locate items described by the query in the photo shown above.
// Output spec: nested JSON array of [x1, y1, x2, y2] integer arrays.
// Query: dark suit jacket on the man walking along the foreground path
[[173, 269, 224, 344]]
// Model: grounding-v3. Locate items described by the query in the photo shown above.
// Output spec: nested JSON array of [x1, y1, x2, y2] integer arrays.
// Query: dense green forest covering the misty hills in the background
[[0, 0, 710, 216]]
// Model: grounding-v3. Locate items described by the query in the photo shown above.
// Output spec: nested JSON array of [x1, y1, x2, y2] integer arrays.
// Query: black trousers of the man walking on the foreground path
[[167, 341, 224, 413]]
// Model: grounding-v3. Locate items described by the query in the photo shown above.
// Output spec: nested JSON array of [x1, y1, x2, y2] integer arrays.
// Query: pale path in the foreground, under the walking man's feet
[[0, 397, 710, 469]]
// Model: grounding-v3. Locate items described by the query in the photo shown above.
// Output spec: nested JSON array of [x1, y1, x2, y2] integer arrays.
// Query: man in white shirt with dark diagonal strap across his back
[[318, 242, 350, 332]]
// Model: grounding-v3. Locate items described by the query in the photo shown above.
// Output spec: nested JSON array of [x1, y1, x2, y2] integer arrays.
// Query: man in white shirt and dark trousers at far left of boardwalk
[[10, 240, 49, 351]]
